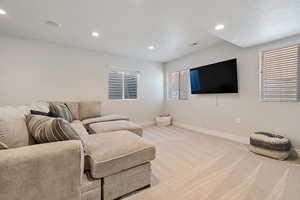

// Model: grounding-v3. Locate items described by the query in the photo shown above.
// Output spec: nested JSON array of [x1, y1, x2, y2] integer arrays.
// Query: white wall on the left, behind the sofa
[[0, 36, 164, 122]]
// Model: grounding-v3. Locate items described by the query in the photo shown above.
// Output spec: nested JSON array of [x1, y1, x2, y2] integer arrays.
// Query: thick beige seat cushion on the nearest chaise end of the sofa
[[86, 131, 155, 178]]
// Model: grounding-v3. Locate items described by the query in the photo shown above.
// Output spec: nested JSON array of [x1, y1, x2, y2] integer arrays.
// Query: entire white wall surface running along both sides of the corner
[[0, 32, 300, 148]]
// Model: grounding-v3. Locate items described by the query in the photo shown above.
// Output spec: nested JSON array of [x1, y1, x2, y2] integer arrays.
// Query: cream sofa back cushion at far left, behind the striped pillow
[[0, 106, 35, 148]]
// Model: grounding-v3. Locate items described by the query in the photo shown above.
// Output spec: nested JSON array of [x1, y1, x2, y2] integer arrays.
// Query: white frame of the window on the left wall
[[107, 66, 141, 101]]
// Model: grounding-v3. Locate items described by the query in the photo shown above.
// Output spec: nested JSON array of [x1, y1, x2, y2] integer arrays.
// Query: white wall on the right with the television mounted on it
[[165, 35, 300, 148]]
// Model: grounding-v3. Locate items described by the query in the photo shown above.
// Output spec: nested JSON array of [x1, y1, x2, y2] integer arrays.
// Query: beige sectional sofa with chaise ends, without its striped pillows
[[0, 101, 155, 200]]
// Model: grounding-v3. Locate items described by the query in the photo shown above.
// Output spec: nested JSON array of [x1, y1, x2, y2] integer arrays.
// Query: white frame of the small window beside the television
[[166, 67, 190, 101]]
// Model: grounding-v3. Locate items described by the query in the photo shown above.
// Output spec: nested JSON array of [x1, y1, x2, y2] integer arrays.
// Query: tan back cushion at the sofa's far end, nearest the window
[[79, 101, 101, 120]]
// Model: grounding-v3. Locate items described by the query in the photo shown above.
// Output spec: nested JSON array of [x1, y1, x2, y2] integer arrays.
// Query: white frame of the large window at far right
[[258, 41, 300, 103]]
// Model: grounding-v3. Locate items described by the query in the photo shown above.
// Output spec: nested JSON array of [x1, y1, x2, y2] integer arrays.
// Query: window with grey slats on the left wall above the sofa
[[108, 68, 139, 100]]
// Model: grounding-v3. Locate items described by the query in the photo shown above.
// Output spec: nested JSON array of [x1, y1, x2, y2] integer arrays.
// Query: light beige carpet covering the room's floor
[[125, 127, 300, 200]]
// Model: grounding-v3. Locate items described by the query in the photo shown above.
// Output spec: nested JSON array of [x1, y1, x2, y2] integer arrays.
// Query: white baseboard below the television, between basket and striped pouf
[[173, 121, 249, 144]]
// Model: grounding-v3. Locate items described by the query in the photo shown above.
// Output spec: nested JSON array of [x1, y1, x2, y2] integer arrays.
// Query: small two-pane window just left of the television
[[168, 70, 189, 100]]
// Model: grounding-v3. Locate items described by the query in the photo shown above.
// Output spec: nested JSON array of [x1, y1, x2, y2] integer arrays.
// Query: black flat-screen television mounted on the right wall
[[190, 59, 238, 94]]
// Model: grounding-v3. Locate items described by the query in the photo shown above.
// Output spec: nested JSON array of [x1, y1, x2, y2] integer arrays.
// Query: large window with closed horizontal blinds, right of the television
[[260, 45, 300, 102]]
